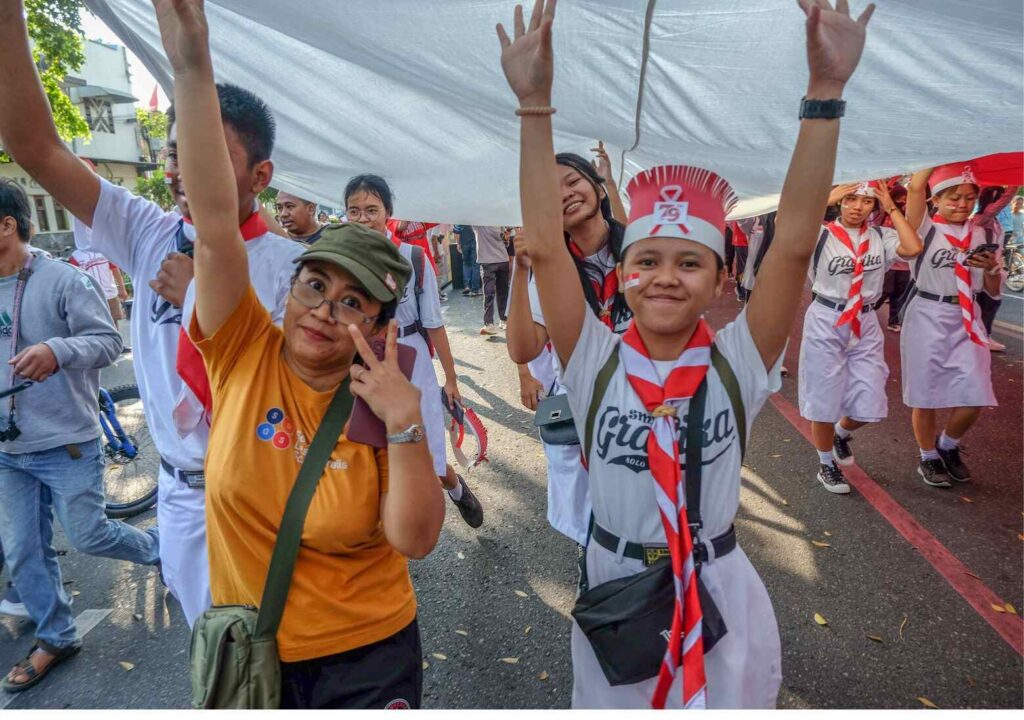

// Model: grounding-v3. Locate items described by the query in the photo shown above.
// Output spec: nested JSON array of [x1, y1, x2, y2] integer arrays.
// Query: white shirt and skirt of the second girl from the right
[[798, 227, 900, 423]]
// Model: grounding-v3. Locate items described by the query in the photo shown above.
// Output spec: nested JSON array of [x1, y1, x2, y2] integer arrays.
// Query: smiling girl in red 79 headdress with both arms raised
[[498, 0, 870, 708]]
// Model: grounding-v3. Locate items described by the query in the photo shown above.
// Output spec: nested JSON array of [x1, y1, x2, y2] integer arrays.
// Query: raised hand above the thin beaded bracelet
[[497, 0, 556, 105]]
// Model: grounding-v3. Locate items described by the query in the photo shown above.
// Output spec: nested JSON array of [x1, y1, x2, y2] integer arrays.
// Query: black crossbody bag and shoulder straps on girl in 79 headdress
[[572, 345, 746, 685]]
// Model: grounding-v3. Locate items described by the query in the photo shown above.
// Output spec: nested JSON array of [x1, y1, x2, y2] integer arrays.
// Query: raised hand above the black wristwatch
[[798, 0, 874, 99]]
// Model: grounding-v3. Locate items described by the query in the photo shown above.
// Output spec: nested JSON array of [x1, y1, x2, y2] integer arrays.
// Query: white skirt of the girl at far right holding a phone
[[899, 296, 998, 409]]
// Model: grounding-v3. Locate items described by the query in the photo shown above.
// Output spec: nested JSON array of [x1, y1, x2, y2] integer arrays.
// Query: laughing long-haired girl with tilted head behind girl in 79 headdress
[[505, 153, 632, 545]]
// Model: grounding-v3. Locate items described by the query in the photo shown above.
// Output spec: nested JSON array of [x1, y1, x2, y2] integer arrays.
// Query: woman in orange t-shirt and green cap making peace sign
[[158, 3, 444, 708]]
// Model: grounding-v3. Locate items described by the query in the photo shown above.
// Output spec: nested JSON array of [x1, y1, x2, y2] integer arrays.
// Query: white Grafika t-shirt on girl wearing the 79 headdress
[[562, 310, 785, 544]]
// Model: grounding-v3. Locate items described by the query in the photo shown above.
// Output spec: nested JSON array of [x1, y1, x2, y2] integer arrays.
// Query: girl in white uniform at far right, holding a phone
[[899, 163, 1002, 488]]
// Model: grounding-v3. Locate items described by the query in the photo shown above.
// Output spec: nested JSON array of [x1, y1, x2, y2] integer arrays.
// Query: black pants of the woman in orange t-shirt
[[281, 620, 423, 710]]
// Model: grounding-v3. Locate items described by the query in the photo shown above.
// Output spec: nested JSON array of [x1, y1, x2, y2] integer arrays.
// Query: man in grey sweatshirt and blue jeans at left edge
[[0, 179, 160, 692]]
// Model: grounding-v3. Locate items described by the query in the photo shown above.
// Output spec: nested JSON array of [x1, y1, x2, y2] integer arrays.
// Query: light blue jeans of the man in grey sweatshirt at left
[[0, 439, 160, 647]]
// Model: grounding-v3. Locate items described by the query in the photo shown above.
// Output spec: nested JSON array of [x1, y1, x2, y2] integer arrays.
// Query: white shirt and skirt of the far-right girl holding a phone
[[899, 215, 998, 409]]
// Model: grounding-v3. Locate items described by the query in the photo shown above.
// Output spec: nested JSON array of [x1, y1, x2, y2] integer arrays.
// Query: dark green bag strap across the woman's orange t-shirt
[[255, 378, 352, 639]]
